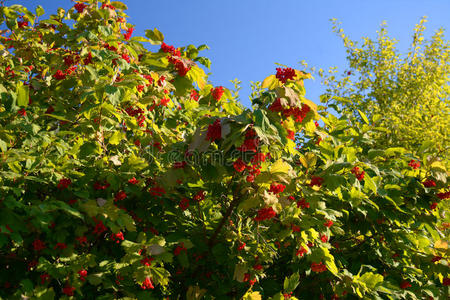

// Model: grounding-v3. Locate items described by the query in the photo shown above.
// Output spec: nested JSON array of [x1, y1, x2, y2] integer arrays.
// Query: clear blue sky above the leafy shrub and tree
[[10, 0, 450, 106]]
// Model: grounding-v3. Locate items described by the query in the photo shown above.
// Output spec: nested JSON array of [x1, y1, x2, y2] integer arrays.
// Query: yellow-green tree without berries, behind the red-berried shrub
[[321, 18, 450, 162]]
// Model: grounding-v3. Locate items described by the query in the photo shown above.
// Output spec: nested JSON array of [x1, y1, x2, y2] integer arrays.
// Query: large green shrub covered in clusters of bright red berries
[[0, 1, 450, 299]]
